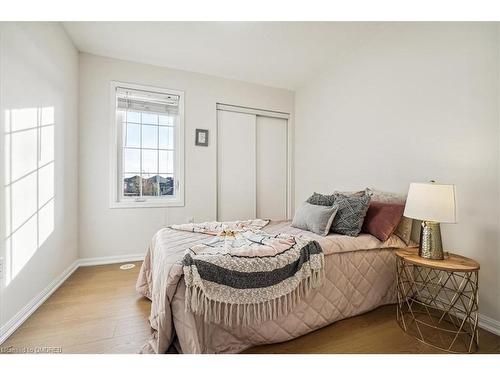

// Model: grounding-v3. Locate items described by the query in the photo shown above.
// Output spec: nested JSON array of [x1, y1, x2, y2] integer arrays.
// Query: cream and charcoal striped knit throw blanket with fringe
[[172, 220, 324, 325]]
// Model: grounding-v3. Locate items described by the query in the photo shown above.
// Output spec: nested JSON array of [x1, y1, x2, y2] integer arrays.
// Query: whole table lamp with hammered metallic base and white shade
[[404, 181, 457, 259]]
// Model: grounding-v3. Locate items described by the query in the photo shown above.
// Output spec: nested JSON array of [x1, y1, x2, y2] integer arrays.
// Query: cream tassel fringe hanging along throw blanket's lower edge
[[185, 268, 324, 326]]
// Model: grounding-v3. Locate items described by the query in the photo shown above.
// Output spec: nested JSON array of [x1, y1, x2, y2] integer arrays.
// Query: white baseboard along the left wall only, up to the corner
[[0, 260, 78, 344]]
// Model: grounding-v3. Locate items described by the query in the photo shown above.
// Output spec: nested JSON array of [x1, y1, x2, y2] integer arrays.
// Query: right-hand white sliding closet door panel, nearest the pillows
[[256, 116, 288, 220]]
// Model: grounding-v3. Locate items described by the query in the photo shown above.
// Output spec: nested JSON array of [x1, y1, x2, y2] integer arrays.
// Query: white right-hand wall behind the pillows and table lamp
[[295, 23, 500, 320]]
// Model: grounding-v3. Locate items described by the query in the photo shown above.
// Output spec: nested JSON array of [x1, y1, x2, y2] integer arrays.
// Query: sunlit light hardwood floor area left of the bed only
[[1, 262, 150, 353]]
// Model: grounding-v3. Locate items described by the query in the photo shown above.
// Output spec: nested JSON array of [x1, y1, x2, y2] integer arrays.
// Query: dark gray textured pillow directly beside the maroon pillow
[[331, 193, 371, 237]]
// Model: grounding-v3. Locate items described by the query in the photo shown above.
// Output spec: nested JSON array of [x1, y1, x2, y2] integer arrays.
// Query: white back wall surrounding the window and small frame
[[79, 54, 294, 258]]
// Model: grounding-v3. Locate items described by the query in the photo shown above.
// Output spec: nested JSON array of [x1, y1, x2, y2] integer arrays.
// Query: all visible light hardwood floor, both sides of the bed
[[0, 262, 500, 354]]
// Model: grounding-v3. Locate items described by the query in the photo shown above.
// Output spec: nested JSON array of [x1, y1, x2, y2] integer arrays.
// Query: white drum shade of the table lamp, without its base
[[404, 183, 457, 223]]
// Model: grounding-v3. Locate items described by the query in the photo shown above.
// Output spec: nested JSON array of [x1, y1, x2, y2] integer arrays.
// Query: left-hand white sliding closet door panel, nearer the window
[[217, 111, 257, 221]]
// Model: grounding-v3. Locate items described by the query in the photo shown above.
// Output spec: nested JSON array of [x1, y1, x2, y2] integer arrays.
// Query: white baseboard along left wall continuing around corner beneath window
[[0, 253, 144, 344]]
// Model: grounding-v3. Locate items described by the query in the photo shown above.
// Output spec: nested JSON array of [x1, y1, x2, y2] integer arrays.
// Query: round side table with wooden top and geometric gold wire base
[[396, 248, 479, 353]]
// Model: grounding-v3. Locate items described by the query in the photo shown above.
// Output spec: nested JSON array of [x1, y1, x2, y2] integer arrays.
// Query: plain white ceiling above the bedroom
[[63, 22, 381, 89]]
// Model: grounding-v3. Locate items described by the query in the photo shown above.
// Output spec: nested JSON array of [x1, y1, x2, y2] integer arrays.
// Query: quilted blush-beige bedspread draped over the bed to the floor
[[136, 222, 406, 353]]
